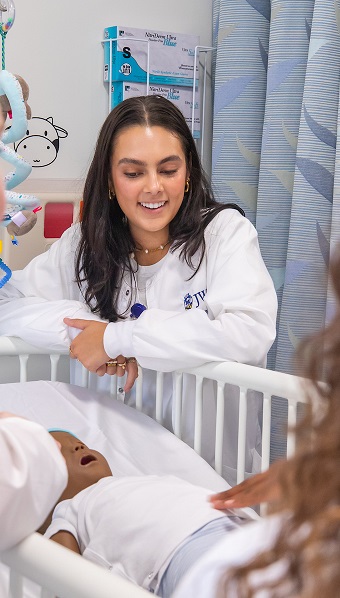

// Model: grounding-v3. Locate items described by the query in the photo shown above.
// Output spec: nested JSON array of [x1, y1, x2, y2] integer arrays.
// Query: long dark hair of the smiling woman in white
[[76, 95, 244, 322]]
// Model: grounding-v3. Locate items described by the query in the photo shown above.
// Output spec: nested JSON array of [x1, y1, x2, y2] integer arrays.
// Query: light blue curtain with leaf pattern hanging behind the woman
[[212, 0, 340, 454]]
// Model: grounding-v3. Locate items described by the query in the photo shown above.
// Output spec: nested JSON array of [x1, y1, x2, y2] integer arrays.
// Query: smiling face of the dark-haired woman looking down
[[111, 125, 188, 246]]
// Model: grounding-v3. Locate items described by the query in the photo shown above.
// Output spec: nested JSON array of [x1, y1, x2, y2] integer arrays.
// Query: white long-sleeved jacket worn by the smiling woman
[[0, 209, 277, 483]]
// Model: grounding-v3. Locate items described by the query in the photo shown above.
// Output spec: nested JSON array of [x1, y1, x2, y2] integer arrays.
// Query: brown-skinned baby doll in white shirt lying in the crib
[[39, 431, 246, 597]]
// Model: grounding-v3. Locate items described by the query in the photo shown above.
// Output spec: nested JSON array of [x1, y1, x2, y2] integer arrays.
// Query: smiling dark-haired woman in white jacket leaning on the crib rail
[[0, 96, 277, 479]]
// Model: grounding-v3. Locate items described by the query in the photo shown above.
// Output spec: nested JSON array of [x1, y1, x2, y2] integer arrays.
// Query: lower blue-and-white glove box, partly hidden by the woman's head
[[111, 81, 201, 139]]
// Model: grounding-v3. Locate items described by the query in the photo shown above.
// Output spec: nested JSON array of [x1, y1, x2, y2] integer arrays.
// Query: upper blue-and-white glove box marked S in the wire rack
[[104, 25, 199, 87]]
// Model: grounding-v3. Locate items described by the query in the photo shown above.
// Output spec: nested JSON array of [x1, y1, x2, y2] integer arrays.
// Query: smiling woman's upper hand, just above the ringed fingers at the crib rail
[[64, 318, 110, 376]]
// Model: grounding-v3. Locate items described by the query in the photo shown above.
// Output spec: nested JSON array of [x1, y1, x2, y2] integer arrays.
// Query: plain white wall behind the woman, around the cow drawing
[[5, 0, 212, 192]]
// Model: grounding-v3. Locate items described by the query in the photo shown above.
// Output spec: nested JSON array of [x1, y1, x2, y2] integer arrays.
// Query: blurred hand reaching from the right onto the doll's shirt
[[210, 461, 285, 509]]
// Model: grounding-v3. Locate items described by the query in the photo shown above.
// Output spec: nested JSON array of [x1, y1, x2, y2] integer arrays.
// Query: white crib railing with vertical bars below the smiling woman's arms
[[0, 336, 305, 482]]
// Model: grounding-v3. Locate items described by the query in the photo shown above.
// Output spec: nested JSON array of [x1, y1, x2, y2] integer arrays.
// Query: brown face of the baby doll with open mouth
[[50, 432, 112, 500]]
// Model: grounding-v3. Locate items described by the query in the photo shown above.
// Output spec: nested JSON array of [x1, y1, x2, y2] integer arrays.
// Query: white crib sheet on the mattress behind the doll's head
[[0, 381, 228, 491]]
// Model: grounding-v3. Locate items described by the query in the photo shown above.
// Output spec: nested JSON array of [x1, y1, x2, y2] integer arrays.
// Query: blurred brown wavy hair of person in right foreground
[[218, 247, 340, 598]]
